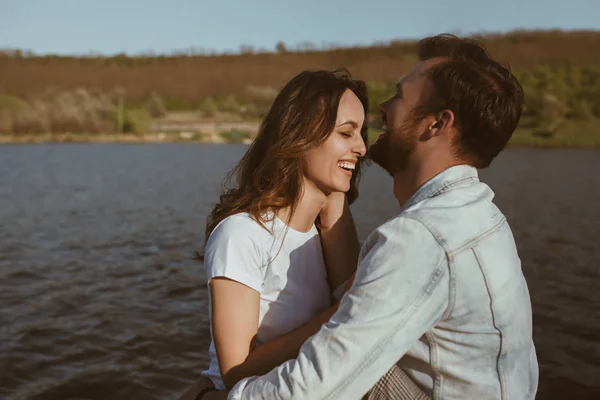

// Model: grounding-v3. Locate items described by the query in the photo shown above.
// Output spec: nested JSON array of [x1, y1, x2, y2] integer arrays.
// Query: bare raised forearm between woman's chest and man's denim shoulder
[[319, 192, 360, 292]]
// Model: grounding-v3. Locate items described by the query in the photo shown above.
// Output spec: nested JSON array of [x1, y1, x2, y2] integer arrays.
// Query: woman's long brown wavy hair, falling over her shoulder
[[198, 69, 369, 260]]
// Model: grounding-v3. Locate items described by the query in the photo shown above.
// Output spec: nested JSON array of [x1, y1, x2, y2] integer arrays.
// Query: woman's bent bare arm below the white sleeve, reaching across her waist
[[210, 278, 338, 388]]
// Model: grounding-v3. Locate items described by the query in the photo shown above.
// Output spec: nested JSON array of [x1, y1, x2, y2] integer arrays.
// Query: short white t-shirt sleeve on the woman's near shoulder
[[204, 216, 264, 292]]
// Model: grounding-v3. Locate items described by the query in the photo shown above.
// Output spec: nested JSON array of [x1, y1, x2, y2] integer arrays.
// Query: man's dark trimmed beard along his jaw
[[369, 120, 419, 176]]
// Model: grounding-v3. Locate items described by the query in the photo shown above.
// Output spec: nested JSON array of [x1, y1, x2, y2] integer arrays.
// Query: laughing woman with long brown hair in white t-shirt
[[182, 71, 428, 399]]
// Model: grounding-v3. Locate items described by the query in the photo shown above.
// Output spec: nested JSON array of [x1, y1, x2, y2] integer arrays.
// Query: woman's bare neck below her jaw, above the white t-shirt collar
[[277, 179, 327, 232]]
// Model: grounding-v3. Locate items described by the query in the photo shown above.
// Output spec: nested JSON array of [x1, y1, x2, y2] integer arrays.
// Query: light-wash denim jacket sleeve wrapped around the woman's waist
[[229, 214, 450, 400]]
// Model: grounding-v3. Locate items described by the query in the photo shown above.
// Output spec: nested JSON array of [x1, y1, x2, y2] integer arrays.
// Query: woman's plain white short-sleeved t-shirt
[[202, 213, 331, 389]]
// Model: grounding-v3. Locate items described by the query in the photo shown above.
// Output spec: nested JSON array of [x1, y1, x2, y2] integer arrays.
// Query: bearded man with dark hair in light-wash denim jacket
[[229, 35, 538, 399]]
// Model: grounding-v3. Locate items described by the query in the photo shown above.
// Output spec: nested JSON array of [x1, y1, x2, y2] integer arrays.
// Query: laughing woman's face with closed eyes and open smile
[[303, 90, 367, 196]]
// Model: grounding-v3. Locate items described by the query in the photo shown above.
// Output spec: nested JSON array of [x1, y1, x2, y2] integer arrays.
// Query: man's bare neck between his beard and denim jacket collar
[[393, 160, 466, 207]]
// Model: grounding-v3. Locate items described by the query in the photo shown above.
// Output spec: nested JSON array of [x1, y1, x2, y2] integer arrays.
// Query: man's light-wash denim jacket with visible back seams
[[229, 165, 538, 400]]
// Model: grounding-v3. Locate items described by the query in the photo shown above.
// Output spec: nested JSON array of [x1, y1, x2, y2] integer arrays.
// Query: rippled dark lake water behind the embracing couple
[[0, 143, 600, 400]]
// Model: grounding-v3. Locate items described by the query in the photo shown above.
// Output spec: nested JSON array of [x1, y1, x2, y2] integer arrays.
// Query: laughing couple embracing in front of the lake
[[181, 35, 538, 400]]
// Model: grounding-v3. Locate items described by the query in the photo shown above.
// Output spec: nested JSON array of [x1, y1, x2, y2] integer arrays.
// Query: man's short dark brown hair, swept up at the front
[[415, 34, 523, 168]]
